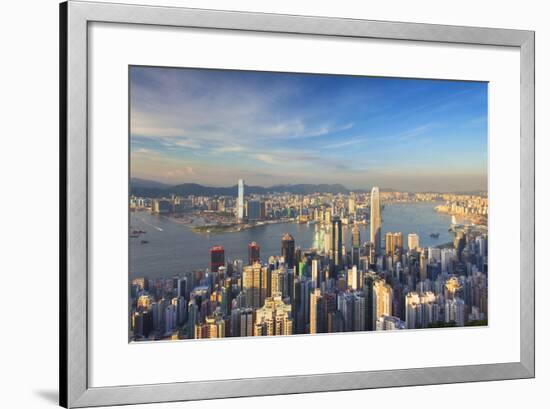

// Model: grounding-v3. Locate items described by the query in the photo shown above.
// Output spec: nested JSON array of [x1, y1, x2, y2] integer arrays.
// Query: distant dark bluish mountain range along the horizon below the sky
[[130, 178, 365, 197]]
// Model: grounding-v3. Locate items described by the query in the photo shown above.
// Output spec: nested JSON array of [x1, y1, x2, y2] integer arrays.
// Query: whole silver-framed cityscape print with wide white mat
[[60, 1, 535, 407]]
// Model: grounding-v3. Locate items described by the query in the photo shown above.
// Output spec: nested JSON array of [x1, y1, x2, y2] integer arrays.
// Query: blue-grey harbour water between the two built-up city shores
[[130, 202, 453, 278]]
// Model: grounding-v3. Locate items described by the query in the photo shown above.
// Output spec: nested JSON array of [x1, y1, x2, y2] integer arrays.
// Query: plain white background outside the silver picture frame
[[0, 0, 550, 409]]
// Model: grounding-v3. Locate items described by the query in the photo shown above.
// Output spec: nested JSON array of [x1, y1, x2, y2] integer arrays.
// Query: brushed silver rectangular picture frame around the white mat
[[60, 1, 535, 408]]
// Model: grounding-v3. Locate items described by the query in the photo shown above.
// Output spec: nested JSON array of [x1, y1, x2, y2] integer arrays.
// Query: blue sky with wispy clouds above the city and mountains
[[130, 67, 487, 191]]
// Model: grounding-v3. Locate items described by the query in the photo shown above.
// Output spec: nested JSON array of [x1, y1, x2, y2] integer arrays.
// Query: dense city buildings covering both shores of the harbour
[[129, 186, 488, 341]]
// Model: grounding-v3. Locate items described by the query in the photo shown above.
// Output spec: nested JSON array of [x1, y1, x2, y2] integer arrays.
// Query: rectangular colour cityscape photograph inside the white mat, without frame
[[129, 66, 489, 341]]
